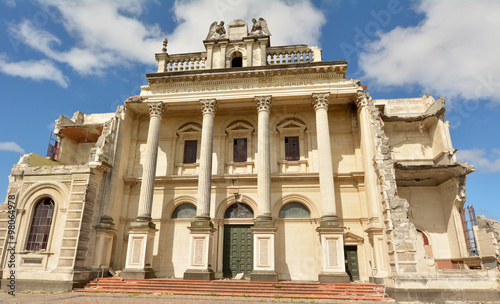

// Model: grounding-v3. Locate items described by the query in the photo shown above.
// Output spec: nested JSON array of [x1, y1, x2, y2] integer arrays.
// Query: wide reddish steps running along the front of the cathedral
[[74, 278, 391, 301]]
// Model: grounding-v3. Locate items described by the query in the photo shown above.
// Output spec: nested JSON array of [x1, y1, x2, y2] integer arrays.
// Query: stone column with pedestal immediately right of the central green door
[[250, 95, 278, 282]]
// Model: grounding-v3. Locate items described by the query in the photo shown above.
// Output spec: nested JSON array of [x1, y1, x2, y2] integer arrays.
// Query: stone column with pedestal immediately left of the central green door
[[184, 99, 217, 280]]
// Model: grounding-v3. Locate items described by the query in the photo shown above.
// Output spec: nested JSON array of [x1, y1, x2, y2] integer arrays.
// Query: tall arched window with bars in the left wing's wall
[[26, 197, 54, 251]]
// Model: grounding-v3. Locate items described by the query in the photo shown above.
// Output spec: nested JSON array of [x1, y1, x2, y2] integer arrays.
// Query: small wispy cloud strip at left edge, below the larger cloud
[[0, 54, 69, 88]]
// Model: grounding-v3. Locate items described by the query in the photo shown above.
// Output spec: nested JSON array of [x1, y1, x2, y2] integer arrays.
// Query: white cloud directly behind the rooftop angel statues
[[168, 0, 326, 53]]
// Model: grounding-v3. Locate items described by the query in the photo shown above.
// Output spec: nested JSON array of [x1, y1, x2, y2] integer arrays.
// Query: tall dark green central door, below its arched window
[[222, 225, 253, 278]]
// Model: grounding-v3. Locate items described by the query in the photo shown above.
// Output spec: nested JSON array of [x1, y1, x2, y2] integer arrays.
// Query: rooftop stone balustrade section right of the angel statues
[[267, 44, 322, 65]]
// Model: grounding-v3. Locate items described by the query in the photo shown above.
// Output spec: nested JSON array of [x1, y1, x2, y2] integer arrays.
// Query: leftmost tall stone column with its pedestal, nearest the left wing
[[122, 101, 164, 279]]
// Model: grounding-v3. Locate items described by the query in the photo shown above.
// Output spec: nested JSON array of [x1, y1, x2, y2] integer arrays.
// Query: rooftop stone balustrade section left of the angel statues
[[157, 52, 207, 73]]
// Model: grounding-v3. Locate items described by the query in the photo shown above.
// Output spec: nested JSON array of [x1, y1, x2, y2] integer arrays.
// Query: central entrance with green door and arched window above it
[[222, 202, 254, 278]]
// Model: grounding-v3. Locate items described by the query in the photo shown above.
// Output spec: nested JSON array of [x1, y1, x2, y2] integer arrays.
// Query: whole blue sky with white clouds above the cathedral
[[0, 0, 500, 219]]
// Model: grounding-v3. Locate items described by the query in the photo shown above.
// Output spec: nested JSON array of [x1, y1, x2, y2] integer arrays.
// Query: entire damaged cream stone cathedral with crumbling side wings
[[0, 18, 500, 299]]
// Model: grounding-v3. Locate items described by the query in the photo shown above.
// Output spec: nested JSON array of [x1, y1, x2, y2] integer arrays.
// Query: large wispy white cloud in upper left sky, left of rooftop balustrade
[[9, 0, 164, 74]]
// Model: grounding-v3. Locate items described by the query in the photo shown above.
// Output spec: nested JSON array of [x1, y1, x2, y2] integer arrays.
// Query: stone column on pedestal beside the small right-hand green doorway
[[312, 92, 349, 283]]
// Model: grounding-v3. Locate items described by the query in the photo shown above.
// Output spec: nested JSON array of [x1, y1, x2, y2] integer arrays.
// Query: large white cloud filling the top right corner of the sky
[[359, 0, 500, 102]]
